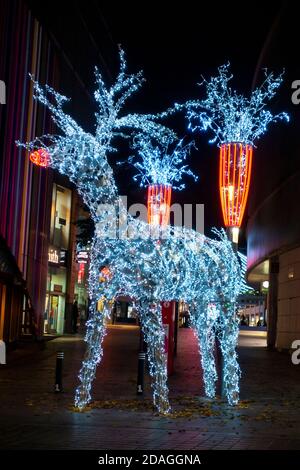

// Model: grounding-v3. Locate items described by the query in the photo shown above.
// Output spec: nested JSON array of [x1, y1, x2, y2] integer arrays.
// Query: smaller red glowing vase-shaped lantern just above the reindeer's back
[[148, 184, 172, 227]]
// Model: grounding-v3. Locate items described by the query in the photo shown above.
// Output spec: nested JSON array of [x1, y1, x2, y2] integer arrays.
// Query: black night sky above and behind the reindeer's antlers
[[29, 0, 286, 246]]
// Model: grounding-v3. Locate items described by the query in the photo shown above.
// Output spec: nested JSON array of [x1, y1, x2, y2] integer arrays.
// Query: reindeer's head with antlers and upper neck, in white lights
[[17, 50, 175, 216]]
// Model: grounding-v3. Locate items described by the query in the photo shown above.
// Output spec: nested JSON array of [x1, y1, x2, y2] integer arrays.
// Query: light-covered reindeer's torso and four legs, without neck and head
[[72, 193, 241, 413]]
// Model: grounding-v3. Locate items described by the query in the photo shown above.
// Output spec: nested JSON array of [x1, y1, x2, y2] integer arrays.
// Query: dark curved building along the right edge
[[247, 5, 300, 350]]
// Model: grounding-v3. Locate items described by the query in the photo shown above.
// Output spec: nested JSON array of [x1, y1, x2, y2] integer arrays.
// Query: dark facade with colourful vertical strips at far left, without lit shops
[[0, 1, 56, 343]]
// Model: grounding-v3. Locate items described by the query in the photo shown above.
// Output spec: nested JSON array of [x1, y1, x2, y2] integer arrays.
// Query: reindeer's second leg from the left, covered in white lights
[[139, 302, 170, 414]]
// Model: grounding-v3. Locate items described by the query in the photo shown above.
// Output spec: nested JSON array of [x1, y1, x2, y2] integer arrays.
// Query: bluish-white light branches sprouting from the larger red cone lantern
[[183, 64, 289, 146]]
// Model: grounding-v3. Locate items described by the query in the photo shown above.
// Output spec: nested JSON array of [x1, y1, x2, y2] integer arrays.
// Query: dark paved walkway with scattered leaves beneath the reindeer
[[0, 326, 300, 450]]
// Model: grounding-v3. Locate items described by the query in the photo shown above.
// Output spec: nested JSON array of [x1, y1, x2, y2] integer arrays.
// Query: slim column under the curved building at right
[[267, 256, 279, 349]]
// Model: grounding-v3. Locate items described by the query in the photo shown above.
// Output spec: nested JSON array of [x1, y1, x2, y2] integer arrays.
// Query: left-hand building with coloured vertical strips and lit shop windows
[[0, 0, 111, 343]]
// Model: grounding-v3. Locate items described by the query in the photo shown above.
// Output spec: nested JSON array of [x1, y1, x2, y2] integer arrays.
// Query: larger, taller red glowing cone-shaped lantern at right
[[219, 143, 253, 227]]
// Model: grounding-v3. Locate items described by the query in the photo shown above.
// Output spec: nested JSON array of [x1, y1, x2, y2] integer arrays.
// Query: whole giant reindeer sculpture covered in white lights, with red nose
[[18, 51, 242, 413]]
